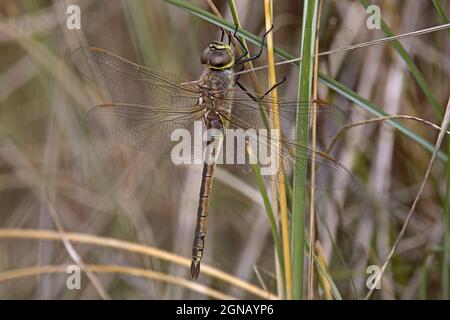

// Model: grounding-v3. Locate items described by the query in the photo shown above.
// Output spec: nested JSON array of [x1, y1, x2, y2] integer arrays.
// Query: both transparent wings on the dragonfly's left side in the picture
[[72, 47, 207, 157]]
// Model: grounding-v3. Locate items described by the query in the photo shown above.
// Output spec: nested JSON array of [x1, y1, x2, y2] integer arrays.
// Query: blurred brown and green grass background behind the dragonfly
[[0, 0, 450, 299]]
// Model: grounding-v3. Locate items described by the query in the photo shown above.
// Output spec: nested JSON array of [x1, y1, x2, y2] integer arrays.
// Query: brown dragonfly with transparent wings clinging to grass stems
[[72, 28, 353, 279]]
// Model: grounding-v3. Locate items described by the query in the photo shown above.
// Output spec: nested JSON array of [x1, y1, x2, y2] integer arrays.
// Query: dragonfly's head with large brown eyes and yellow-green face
[[200, 41, 235, 70]]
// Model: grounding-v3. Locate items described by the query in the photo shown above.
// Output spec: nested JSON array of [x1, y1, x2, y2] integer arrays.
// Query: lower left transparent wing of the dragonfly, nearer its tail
[[87, 104, 204, 157]]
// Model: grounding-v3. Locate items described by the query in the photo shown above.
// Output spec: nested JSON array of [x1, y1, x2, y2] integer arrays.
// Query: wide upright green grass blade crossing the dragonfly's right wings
[[291, 0, 318, 299]]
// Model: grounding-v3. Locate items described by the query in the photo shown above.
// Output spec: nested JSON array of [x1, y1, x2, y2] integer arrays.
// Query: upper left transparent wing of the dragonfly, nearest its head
[[72, 47, 198, 109]]
